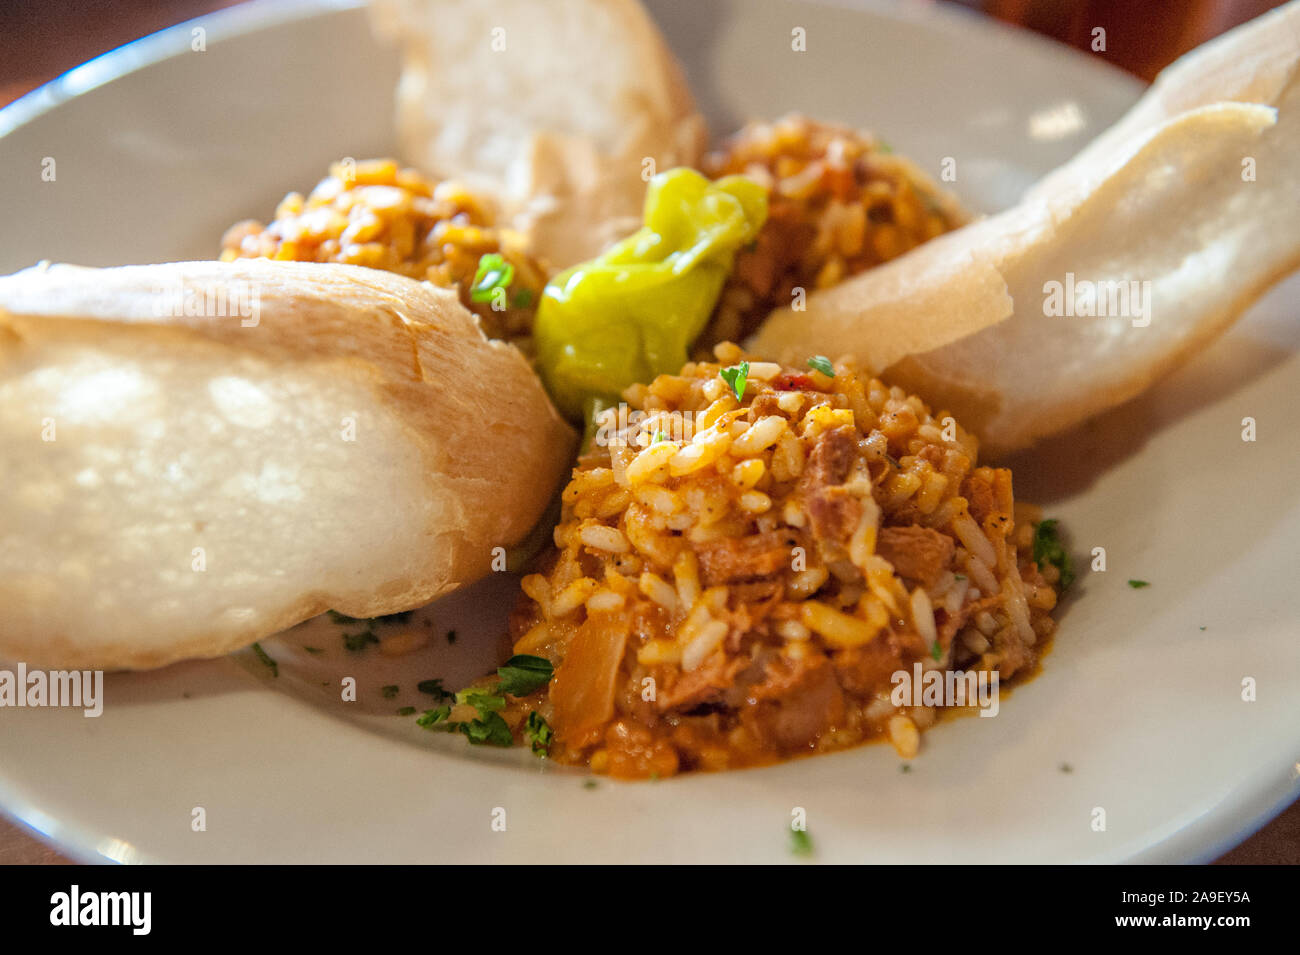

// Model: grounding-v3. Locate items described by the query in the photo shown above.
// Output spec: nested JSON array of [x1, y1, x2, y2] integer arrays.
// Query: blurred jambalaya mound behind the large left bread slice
[[221, 160, 547, 350]]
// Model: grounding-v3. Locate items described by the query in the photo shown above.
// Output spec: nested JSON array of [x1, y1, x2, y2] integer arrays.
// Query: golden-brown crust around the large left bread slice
[[0, 260, 576, 668]]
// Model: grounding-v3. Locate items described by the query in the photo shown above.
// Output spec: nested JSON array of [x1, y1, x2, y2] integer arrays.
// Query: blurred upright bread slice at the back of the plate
[[372, 0, 707, 269]]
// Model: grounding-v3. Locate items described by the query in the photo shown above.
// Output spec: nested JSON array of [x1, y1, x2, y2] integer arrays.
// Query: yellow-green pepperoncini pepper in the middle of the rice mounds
[[533, 169, 767, 420]]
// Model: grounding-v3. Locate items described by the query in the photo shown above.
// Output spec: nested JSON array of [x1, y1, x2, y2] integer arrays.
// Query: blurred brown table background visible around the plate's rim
[[0, 0, 1300, 865]]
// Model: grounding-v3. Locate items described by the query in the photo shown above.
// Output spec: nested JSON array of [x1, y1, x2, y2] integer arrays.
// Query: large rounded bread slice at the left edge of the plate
[[0, 260, 575, 668]]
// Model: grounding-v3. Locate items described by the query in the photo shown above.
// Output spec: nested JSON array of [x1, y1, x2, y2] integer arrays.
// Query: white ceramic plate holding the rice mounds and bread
[[0, 0, 1300, 863]]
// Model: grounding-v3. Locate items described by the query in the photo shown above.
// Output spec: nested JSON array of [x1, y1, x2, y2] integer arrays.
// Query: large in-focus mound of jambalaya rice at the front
[[504, 343, 1057, 778]]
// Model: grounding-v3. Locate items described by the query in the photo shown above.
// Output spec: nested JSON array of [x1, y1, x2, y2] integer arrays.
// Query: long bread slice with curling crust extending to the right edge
[[750, 0, 1300, 455]]
